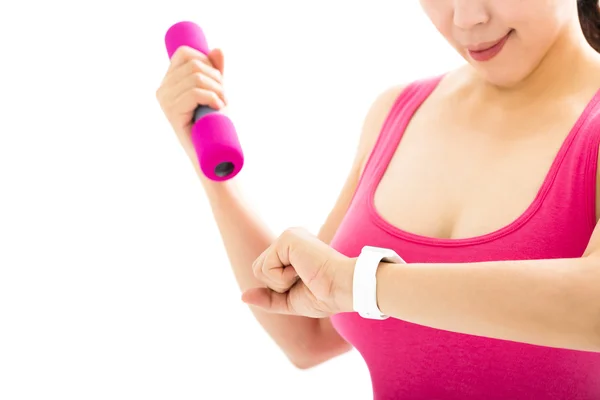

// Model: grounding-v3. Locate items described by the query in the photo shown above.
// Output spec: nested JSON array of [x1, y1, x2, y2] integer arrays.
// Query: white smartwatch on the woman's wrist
[[352, 246, 404, 319]]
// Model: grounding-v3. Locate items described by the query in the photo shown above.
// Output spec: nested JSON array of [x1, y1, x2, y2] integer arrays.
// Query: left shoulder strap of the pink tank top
[[359, 75, 444, 191]]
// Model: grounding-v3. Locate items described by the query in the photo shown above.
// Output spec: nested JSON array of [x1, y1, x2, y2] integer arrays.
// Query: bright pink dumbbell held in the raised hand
[[165, 21, 244, 181]]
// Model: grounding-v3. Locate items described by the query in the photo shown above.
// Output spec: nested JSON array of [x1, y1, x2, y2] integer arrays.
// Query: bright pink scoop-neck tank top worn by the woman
[[332, 77, 600, 400]]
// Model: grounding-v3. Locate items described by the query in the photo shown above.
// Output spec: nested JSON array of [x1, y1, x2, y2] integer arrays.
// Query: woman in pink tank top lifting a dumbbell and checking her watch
[[157, 0, 600, 400]]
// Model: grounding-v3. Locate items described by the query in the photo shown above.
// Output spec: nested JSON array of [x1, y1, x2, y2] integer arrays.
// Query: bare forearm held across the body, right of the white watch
[[377, 257, 600, 351]]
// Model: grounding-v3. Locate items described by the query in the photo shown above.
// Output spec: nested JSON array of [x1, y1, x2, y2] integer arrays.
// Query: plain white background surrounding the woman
[[0, 0, 461, 400]]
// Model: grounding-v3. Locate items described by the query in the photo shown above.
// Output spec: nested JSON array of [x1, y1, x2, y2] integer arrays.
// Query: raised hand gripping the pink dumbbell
[[156, 46, 227, 170]]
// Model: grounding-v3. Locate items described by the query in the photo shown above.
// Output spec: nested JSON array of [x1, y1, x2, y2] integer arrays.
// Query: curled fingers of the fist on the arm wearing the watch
[[252, 246, 299, 293]]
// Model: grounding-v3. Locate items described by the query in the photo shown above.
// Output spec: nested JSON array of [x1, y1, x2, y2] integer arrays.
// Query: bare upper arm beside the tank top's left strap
[[318, 85, 405, 243]]
